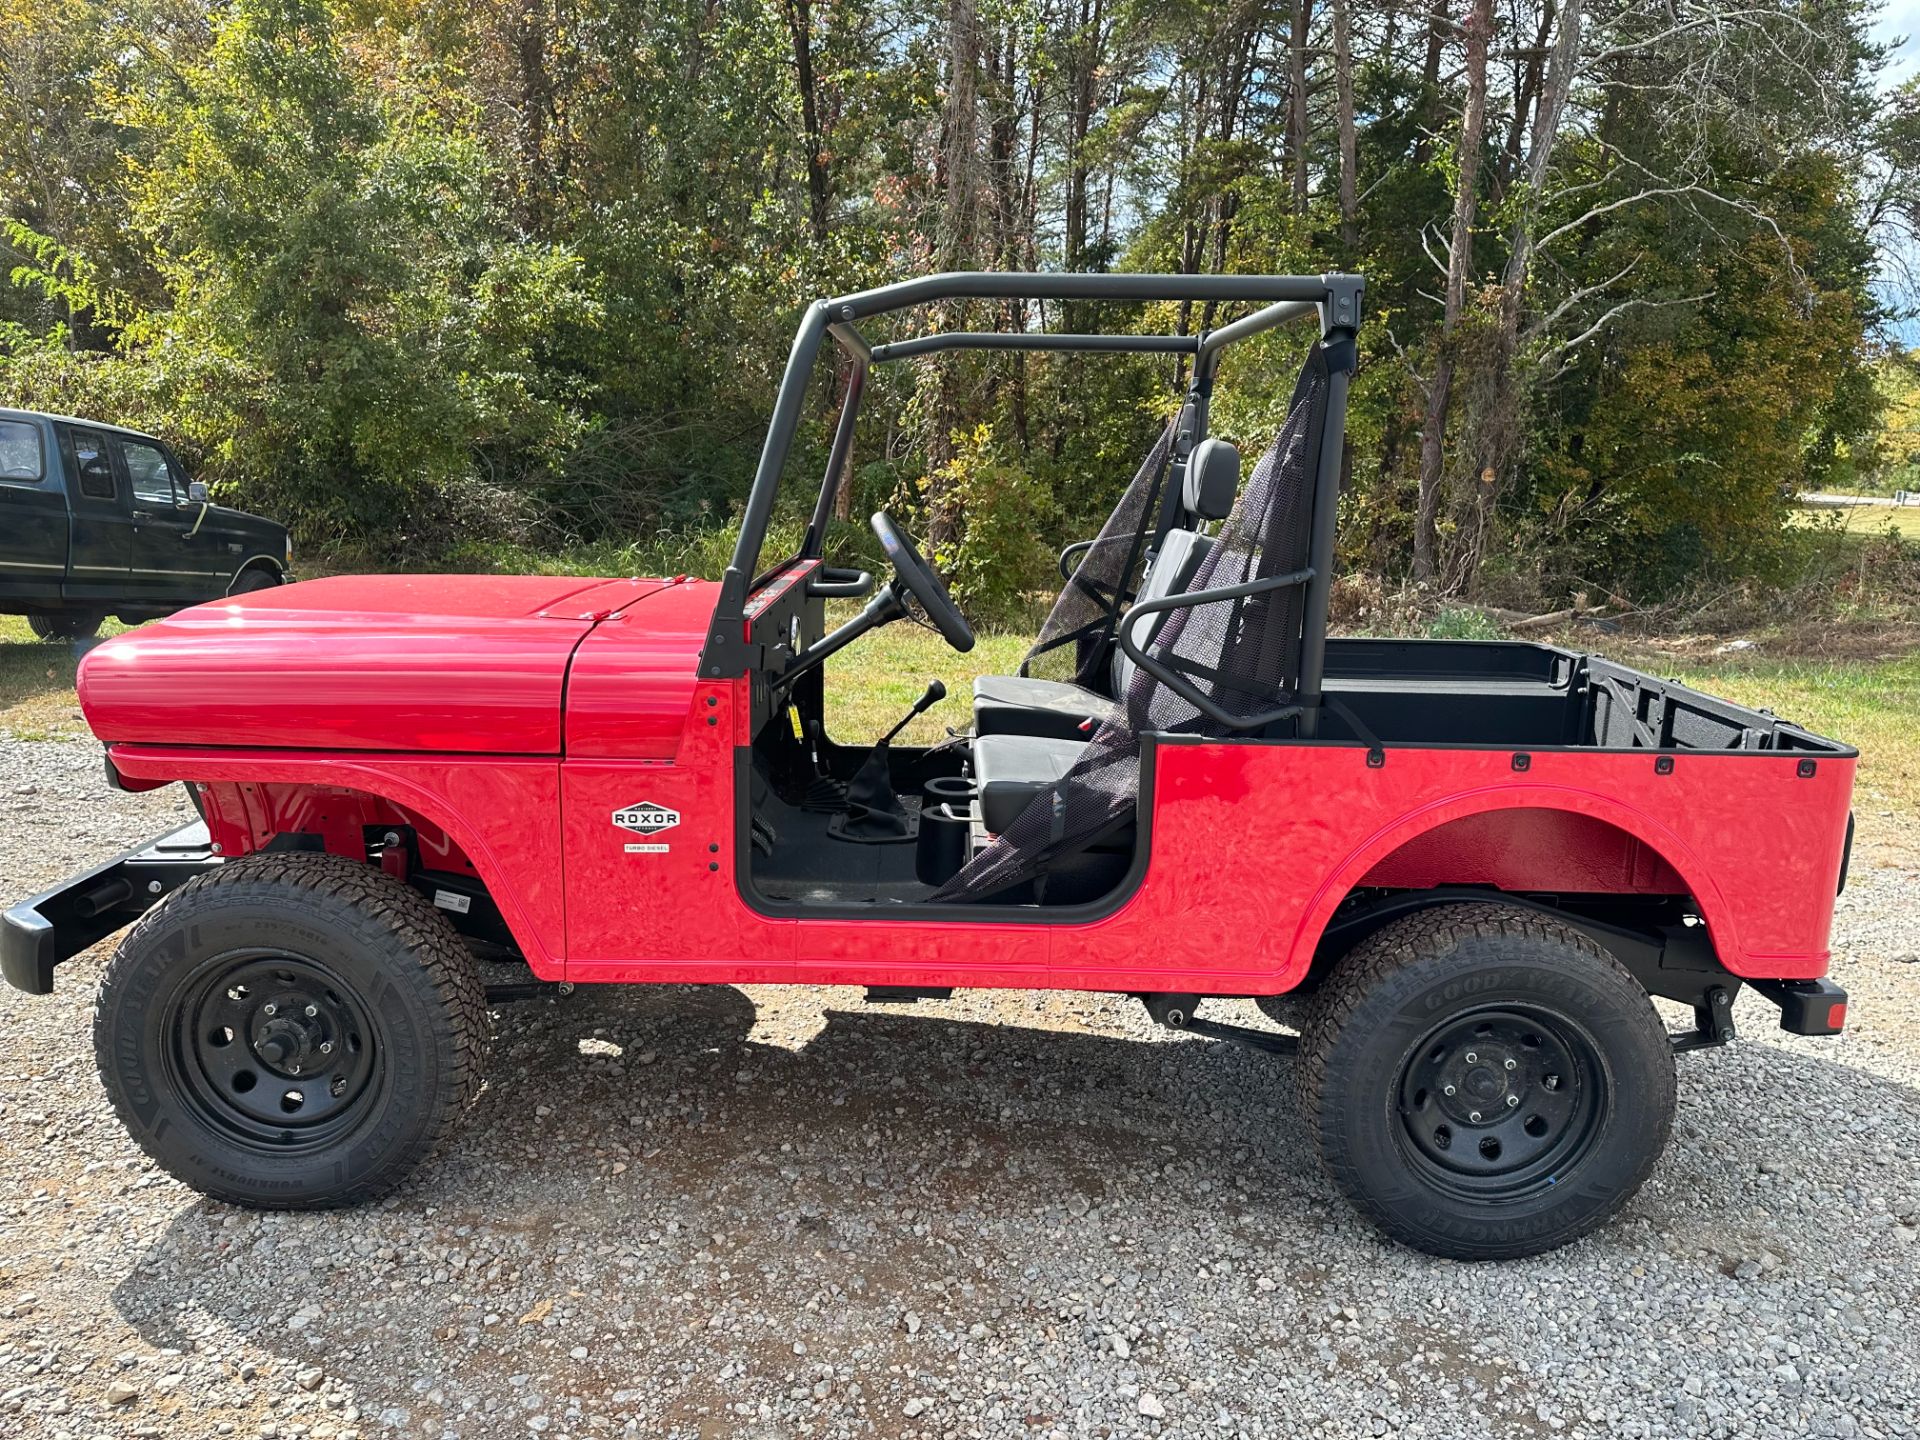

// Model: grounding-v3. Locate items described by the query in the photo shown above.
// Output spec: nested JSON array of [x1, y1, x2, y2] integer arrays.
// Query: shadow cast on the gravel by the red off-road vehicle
[[113, 987, 1920, 1436]]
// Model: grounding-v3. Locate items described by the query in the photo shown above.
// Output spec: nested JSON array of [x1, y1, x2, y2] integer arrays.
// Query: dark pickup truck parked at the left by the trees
[[0, 409, 294, 639]]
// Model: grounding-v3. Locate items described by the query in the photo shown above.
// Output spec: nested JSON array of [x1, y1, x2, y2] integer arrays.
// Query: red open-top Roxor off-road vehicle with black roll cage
[[4, 275, 1855, 1258]]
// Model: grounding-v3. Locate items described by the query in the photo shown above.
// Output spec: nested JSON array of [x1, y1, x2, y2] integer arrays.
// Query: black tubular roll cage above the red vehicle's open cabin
[[699, 271, 1367, 735]]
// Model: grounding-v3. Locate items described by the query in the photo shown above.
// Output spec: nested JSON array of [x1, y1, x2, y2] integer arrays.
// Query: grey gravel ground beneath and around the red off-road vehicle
[[0, 739, 1920, 1440]]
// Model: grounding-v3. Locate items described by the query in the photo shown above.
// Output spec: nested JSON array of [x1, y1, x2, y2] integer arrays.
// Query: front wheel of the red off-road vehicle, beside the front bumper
[[94, 852, 488, 1210]]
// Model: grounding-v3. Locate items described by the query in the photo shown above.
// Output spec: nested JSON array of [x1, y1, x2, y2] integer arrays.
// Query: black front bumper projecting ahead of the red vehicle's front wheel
[[0, 820, 221, 995]]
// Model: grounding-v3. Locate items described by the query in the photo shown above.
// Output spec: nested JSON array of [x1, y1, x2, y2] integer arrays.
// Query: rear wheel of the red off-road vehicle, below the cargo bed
[[1300, 902, 1674, 1260]]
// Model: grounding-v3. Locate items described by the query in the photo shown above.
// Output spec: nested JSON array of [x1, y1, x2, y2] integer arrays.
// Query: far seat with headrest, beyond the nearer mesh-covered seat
[[973, 440, 1240, 744]]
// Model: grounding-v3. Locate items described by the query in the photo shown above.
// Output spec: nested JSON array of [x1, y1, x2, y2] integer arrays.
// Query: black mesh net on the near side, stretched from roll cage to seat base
[[933, 346, 1329, 900]]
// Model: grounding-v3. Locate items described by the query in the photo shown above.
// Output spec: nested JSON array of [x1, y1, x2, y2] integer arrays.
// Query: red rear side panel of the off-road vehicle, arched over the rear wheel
[[1054, 743, 1853, 993]]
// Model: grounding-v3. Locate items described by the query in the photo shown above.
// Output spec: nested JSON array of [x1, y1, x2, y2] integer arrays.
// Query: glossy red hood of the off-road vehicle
[[79, 574, 710, 755]]
